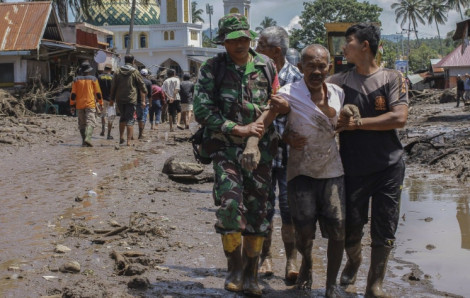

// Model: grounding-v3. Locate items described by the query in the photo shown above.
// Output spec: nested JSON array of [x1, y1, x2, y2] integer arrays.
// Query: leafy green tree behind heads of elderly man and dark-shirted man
[[290, 0, 382, 50]]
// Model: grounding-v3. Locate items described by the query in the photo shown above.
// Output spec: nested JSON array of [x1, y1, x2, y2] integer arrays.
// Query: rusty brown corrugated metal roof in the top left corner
[[0, 2, 52, 51]]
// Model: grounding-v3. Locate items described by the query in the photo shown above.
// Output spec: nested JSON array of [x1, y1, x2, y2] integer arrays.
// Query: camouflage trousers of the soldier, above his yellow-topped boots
[[211, 147, 273, 236]]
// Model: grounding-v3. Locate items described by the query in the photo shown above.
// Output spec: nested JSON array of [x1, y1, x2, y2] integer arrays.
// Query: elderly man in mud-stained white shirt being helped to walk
[[279, 44, 345, 297]]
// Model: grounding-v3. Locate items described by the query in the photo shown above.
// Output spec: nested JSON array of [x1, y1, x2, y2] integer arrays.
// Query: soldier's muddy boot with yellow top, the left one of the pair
[[222, 233, 243, 292]]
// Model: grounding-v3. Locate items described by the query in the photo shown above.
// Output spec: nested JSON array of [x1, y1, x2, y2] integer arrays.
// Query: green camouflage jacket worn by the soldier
[[194, 50, 279, 162]]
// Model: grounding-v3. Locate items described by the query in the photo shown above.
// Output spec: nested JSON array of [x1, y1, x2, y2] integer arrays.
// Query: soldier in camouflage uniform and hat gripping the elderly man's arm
[[194, 14, 286, 296]]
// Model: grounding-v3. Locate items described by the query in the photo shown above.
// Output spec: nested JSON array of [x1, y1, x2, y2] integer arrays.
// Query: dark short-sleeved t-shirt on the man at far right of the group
[[328, 68, 408, 176]]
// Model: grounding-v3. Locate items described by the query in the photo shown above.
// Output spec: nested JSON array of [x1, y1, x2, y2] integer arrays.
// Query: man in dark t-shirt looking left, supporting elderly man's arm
[[328, 24, 408, 297]]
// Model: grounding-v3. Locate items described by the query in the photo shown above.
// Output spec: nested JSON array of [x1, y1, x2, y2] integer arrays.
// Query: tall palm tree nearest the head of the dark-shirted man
[[391, 0, 425, 56]]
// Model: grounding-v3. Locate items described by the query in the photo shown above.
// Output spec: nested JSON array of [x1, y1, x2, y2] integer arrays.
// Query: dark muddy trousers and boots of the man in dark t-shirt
[[341, 160, 405, 297]]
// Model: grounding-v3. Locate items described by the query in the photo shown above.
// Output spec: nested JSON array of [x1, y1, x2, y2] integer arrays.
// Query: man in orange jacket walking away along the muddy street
[[70, 62, 103, 147]]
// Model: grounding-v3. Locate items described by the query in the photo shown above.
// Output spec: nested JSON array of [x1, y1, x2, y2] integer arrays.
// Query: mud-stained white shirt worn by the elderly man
[[279, 80, 344, 181]]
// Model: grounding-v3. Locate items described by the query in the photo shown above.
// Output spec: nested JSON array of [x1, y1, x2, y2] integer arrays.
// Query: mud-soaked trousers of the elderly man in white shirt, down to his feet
[[287, 176, 345, 297]]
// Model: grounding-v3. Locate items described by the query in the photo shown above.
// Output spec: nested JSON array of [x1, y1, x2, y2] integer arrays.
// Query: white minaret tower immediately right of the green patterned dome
[[160, 0, 192, 24]]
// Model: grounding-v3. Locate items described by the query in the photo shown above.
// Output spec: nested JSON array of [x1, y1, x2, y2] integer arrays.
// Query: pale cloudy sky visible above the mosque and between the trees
[[195, 0, 461, 37]]
